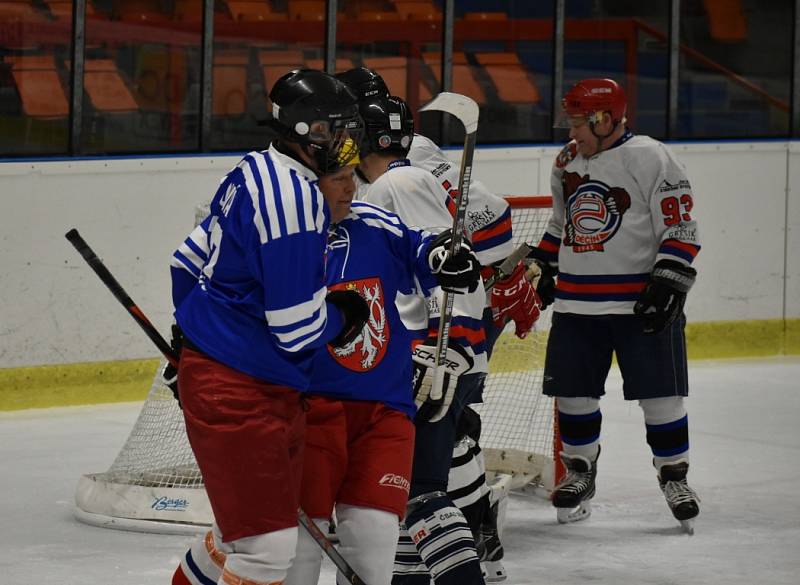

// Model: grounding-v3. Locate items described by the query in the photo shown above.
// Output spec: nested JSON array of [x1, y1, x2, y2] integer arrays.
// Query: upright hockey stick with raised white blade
[[419, 91, 480, 400]]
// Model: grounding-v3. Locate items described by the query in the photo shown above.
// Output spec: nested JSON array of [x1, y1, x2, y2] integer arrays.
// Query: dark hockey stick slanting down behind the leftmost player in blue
[[64, 228, 366, 585]]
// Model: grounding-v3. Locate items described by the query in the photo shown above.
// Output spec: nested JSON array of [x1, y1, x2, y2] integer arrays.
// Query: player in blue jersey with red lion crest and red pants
[[170, 143, 479, 585]]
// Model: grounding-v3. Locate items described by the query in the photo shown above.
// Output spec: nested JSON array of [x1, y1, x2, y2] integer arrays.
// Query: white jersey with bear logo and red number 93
[[539, 132, 700, 315]]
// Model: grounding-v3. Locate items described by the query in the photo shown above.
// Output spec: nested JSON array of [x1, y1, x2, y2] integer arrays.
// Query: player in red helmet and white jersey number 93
[[533, 79, 700, 531]]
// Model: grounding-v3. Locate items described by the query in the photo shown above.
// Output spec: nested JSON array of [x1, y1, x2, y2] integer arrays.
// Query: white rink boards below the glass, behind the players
[[0, 141, 800, 368]]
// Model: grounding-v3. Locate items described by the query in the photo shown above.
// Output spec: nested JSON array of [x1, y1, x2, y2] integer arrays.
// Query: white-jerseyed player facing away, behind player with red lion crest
[[360, 91, 487, 585]]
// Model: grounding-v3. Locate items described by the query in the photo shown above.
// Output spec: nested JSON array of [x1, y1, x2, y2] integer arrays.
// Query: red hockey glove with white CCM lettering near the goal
[[490, 262, 542, 339]]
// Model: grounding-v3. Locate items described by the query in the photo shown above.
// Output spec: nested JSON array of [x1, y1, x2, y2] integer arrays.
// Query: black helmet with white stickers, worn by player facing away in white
[[359, 96, 414, 157]]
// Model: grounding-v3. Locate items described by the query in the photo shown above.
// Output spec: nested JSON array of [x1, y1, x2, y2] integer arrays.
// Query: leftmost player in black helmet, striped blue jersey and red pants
[[172, 70, 369, 585]]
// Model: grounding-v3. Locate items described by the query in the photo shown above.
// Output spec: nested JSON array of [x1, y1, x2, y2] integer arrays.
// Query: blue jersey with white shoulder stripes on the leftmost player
[[171, 147, 343, 390]]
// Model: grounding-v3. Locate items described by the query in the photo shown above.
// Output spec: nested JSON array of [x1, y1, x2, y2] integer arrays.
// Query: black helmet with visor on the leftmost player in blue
[[267, 69, 364, 175]]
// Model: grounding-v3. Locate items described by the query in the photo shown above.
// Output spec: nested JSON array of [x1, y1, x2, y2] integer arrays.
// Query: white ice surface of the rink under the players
[[0, 358, 800, 585]]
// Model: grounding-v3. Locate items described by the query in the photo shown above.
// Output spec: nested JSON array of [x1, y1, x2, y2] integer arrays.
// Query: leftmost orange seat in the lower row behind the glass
[[5, 55, 69, 118]]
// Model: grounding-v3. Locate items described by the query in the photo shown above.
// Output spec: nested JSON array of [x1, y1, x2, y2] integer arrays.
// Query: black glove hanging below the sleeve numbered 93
[[633, 260, 697, 333]]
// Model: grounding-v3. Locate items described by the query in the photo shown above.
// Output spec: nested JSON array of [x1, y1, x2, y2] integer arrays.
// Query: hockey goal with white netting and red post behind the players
[[75, 196, 554, 534]]
